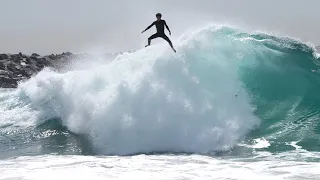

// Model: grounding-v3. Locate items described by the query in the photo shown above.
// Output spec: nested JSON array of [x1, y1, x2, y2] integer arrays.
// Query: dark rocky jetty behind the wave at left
[[0, 52, 78, 88]]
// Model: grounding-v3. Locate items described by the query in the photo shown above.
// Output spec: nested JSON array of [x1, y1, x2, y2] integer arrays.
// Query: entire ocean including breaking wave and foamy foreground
[[0, 25, 320, 180]]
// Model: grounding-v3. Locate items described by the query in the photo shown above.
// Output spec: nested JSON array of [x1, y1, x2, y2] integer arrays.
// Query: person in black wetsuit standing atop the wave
[[141, 13, 176, 52]]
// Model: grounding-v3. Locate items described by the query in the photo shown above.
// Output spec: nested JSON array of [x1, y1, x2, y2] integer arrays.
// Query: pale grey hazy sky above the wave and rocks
[[0, 0, 320, 55]]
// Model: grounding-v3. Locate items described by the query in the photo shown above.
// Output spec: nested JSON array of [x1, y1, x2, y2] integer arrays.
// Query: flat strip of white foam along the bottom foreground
[[0, 155, 320, 180]]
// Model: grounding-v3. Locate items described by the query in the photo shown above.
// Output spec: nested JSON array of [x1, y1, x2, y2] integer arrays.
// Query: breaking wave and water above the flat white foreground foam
[[0, 26, 320, 161]]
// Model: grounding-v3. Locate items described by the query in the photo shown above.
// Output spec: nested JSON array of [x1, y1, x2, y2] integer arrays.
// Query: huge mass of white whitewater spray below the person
[[9, 27, 259, 155]]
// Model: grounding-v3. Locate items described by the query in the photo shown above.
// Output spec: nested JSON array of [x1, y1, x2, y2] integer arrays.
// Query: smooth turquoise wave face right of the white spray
[[241, 34, 320, 152]]
